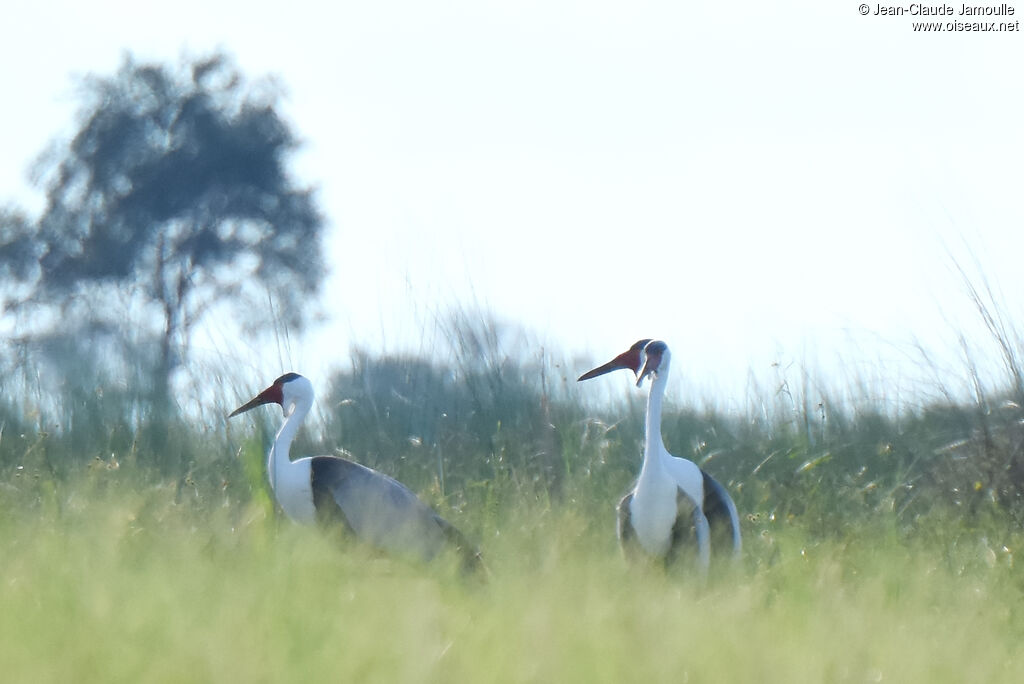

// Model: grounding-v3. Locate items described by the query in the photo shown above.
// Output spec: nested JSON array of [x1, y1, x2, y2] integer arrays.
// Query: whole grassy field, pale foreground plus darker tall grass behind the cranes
[[0, 307, 1024, 682]]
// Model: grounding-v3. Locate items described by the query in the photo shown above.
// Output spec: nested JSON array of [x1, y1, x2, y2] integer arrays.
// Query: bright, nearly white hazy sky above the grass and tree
[[0, 0, 1024, 405]]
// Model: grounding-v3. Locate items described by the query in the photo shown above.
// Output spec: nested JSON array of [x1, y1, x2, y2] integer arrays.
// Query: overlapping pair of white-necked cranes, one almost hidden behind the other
[[580, 339, 742, 571]]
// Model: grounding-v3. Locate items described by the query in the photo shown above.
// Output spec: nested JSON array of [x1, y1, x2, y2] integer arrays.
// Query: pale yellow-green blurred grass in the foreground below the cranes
[[0, 472, 1024, 683]]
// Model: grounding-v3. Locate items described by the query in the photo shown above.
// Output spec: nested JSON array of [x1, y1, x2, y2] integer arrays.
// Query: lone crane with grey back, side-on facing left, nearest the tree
[[228, 373, 482, 570]]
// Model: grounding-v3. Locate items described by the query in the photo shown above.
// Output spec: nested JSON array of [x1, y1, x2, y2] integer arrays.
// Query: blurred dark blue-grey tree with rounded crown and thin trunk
[[0, 53, 325, 412]]
